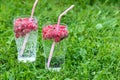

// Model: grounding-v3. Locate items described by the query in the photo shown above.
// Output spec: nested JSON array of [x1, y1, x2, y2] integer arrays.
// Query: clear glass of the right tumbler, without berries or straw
[[43, 24, 67, 71]]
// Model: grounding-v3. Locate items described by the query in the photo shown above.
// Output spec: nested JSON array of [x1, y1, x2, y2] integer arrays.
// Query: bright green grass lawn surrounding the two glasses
[[0, 0, 120, 80]]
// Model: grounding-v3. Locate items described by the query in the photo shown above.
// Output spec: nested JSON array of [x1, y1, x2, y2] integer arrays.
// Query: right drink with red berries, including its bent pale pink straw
[[42, 5, 74, 71]]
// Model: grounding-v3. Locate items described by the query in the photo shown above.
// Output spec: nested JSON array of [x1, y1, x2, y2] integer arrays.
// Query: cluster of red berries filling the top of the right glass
[[42, 24, 68, 42]]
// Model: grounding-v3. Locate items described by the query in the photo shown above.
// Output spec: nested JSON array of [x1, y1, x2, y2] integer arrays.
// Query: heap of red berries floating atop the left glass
[[14, 18, 38, 38]]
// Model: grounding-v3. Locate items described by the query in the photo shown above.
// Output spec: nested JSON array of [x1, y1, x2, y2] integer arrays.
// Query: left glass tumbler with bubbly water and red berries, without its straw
[[14, 17, 38, 62]]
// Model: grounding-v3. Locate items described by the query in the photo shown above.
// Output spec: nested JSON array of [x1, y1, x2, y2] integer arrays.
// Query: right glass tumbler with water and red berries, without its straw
[[42, 24, 68, 70]]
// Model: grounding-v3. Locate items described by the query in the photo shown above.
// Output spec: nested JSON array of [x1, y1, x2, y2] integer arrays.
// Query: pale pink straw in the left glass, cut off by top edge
[[20, 0, 38, 56]]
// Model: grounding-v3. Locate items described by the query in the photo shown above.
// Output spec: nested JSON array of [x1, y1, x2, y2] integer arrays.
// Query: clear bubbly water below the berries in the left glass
[[15, 31, 38, 62]]
